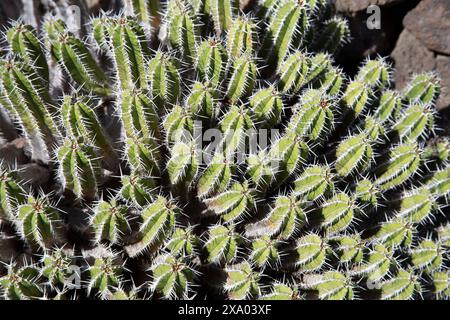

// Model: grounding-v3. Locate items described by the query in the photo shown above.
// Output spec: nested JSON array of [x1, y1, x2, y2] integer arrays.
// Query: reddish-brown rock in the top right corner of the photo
[[403, 0, 450, 55]]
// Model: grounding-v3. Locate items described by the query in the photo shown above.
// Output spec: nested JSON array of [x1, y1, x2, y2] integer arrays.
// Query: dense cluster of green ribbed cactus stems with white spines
[[0, 0, 450, 300]]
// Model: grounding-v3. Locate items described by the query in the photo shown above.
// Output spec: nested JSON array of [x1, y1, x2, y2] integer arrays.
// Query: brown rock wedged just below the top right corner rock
[[391, 29, 436, 89]]
